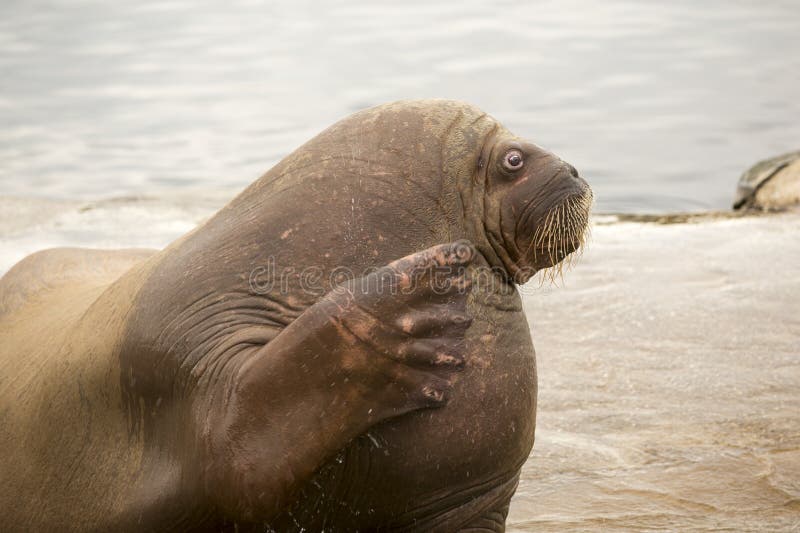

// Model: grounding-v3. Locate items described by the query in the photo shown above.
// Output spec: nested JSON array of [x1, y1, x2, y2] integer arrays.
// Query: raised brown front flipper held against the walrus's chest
[[197, 241, 476, 522]]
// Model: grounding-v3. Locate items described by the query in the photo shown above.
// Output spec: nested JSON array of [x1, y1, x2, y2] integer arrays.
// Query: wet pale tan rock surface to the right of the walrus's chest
[[509, 215, 800, 531]]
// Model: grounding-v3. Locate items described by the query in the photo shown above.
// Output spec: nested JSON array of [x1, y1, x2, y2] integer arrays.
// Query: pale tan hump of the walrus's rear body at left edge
[[0, 248, 156, 315]]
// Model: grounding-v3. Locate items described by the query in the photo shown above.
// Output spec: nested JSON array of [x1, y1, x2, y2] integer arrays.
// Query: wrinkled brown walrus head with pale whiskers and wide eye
[[477, 128, 593, 283]]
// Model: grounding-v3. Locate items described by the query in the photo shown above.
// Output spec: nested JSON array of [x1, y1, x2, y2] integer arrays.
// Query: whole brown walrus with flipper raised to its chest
[[0, 100, 592, 531]]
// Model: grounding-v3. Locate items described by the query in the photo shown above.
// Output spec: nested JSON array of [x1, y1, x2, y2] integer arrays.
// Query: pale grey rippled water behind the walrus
[[0, 0, 800, 212]]
